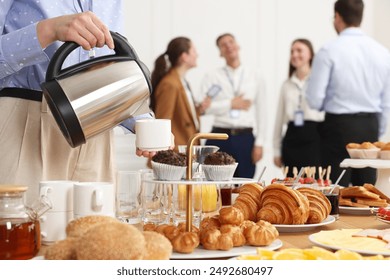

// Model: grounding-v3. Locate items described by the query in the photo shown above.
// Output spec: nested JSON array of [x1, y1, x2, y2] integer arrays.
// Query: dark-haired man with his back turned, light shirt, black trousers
[[306, 0, 390, 186]]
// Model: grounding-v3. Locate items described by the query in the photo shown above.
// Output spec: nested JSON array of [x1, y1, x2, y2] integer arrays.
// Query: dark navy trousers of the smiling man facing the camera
[[206, 129, 256, 178]]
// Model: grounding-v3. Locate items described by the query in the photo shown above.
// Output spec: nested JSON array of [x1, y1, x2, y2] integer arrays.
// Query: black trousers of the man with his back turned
[[319, 113, 379, 186]]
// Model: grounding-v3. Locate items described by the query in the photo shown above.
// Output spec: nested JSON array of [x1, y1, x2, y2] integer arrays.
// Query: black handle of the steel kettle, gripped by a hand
[[46, 31, 138, 81]]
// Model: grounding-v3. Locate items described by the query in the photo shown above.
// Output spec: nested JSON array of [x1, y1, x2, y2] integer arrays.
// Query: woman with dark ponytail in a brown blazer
[[151, 37, 210, 151]]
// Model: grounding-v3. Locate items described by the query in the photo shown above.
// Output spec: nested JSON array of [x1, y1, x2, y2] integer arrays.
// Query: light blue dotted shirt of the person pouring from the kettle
[[0, 0, 151, 131]]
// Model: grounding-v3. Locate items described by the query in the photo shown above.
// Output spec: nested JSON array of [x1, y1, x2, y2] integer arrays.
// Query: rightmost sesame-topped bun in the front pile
[[143, 231, 172, 260]]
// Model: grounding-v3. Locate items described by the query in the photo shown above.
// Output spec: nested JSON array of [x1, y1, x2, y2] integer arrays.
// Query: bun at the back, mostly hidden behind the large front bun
[[66, 215, 119, 237]]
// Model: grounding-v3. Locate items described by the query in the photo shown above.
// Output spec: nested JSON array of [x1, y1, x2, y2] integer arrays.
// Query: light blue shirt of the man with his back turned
[[306, 28, 390, 135]]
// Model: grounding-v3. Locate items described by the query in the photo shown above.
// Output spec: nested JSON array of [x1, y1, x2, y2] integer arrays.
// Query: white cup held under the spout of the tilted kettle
[[135, 119, 172, 151]]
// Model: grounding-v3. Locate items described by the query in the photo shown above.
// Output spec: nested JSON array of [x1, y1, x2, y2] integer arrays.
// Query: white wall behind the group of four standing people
[[118, 0, 390, 182]]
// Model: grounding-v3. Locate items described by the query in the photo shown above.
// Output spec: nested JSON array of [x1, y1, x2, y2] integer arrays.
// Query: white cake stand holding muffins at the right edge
[[340, 158, 390, 196]]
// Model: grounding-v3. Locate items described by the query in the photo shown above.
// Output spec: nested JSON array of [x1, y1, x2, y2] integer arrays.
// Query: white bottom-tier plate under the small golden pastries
[[171, 239, 283, 260]]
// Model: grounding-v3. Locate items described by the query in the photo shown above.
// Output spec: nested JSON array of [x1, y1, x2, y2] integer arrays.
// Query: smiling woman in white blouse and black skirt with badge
[[273, 39, 324, 177]]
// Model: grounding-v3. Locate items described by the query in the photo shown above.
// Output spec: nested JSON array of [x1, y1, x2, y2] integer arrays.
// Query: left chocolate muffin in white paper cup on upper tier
[[151, 150, 187, 181]]
